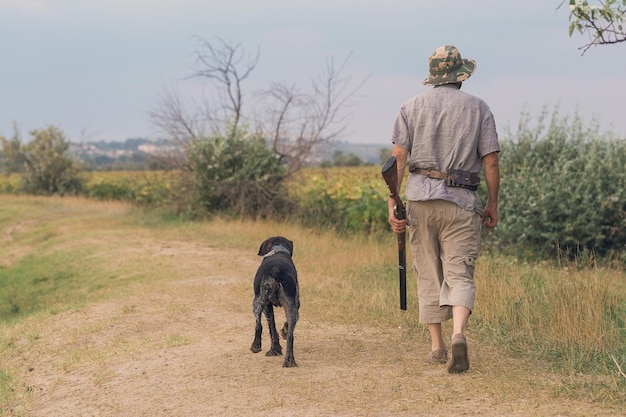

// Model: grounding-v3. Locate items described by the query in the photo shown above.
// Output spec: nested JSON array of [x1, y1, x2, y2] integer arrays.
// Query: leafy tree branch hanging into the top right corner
[[559, 0, 626, 55]]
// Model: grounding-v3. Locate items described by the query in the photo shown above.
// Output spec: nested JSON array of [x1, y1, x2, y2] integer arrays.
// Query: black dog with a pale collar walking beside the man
[[250, 236, 300, 367]]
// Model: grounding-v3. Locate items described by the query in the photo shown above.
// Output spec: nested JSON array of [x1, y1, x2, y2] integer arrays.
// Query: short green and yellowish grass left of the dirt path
[[0, 196, 183, 322]]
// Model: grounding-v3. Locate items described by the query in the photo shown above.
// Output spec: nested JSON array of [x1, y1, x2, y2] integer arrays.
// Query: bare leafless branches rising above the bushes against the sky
[[150, 37, 365, 172]]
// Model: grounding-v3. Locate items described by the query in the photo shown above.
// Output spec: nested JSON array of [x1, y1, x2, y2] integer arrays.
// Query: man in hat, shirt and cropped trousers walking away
[[388, 45, 500, 373]]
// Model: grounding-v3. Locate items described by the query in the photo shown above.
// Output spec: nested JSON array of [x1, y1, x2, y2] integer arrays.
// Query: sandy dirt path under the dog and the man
[[3, 242, 619, 417]]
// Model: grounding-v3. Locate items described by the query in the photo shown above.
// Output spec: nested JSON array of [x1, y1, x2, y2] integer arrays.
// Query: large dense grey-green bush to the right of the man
[[490, 110, 626, 257]]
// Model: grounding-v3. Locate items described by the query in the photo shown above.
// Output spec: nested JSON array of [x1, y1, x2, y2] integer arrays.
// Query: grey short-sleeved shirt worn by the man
[[391, 85, 500, 215]]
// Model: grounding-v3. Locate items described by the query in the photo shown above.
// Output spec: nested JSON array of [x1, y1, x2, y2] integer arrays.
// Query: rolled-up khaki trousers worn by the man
[[408, 200, 481, 323]]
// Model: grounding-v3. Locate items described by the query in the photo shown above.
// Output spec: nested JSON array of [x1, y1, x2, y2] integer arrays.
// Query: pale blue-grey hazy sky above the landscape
[[0, 0, 626, 144]]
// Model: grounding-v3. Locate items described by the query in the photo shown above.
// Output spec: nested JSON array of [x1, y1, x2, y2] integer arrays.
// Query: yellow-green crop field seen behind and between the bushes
[[0, 166, 389, 233]]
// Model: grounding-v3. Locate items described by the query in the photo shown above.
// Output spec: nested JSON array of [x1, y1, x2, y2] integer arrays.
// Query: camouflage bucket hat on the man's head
[[424, 45, 476, 86]]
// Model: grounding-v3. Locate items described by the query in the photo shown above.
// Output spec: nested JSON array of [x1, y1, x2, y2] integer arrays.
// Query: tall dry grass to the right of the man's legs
[[474, 257, 626, 402]]
